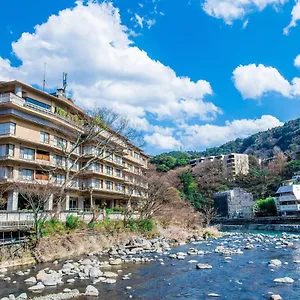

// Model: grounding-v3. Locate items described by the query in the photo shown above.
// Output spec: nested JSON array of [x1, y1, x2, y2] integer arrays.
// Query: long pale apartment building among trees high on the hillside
[[190, 153, 249, 176]]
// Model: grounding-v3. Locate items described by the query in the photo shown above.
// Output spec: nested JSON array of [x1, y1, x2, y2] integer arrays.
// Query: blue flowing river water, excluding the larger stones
[[0, 233, 300, 300]]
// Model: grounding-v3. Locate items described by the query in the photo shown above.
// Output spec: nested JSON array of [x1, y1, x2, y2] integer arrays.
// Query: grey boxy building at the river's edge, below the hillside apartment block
[[214, 188, 254, 219]]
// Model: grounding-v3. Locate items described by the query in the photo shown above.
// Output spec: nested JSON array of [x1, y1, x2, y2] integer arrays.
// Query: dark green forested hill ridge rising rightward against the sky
[[151, 118, 300, 171]]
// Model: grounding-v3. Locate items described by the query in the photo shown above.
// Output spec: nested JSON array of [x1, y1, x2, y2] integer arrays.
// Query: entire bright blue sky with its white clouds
[[0, 0, 300, 155]]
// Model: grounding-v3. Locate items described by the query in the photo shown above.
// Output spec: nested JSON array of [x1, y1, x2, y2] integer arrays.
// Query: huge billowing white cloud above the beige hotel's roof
[[0, 1, 221, 127]]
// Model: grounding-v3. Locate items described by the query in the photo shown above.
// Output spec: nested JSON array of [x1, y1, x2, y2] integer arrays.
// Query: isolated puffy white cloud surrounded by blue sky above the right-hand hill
[[233, 64, 293, 99]]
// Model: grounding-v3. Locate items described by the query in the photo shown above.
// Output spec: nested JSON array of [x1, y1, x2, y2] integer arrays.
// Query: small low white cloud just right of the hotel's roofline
[[145, 133, 181, 150]]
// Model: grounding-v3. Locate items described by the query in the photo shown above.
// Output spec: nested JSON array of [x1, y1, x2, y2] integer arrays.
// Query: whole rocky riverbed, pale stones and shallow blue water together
[[0, 233, 300, 300]]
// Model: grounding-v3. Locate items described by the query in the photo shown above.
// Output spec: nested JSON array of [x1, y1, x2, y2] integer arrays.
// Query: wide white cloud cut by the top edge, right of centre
[[202, 0, 289, 25]]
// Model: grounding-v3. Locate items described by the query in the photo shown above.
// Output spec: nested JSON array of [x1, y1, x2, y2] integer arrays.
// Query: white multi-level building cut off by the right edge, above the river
[[276, 173, 300, 216]]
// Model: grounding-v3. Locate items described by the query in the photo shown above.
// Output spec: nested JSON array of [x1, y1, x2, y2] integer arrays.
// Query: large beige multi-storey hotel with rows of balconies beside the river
[[0, 81, 149, 211]]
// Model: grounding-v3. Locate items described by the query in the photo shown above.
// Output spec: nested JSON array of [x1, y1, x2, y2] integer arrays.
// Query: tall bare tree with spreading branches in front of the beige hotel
[[50, 109, 142, 216]]
